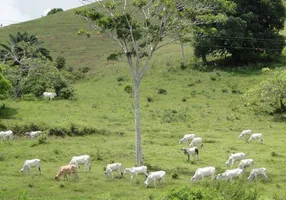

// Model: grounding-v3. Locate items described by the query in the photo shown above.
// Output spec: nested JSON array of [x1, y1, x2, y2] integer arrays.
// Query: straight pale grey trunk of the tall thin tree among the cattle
[[134, 78, 143, 166]]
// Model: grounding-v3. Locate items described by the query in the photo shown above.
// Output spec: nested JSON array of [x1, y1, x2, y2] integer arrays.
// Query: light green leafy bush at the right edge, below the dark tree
[[245, 70, 286, 113]]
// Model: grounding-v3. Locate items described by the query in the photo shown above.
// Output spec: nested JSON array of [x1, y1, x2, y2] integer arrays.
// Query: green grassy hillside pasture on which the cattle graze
[[0, 4, 286, 200]]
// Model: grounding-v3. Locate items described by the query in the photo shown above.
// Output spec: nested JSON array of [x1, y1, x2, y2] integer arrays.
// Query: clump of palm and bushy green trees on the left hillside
[[0, 32, 73, 99]]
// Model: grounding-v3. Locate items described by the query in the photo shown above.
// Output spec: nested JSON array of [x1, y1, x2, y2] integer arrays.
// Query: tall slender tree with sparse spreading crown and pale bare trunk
[[76, 0, 212, 165]]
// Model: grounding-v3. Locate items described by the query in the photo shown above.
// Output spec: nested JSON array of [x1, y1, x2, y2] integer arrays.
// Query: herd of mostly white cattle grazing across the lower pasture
[[0, 130, 267, 188]]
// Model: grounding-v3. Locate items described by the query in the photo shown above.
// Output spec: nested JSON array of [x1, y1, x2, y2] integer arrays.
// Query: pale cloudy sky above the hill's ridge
[[0, 0, 83, 26]]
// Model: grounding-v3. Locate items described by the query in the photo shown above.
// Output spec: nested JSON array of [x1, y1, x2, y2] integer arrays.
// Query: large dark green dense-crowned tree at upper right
[[194, 0, 286, 62]]
